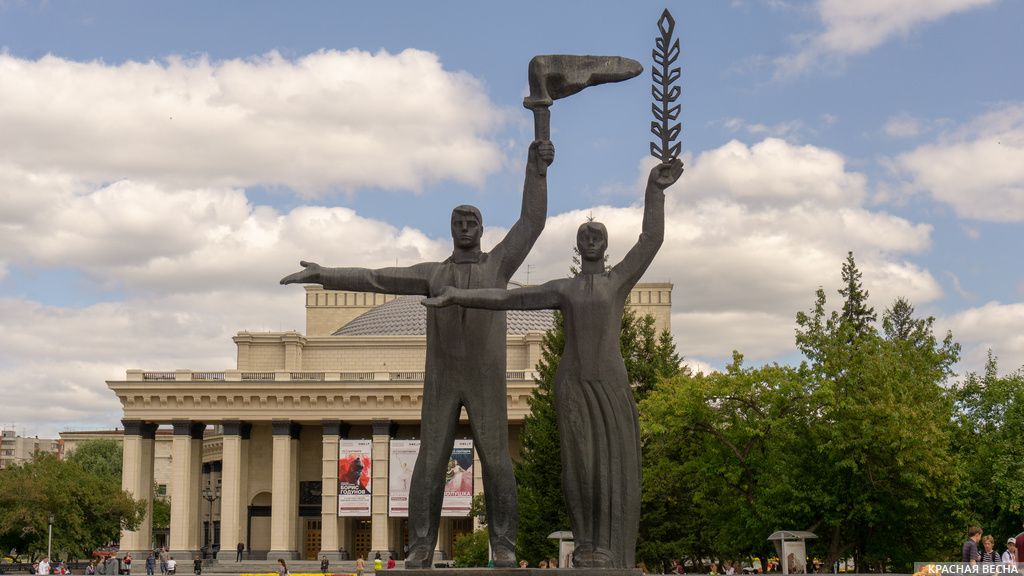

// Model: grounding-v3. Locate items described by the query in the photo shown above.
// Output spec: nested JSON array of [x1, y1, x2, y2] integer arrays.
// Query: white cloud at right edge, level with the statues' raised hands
[[893, 102, 1024, 221]]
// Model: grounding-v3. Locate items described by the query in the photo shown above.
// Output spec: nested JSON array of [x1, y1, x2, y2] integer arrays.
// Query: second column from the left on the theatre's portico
[[170, 420, 206, 561]]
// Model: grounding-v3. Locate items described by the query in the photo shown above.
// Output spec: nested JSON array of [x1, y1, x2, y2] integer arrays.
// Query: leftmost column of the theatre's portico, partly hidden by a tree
[[121, 420, 157, 558]]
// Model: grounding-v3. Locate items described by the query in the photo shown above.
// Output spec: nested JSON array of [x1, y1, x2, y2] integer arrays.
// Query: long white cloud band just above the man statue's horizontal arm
[[0, 169, 445, 294]]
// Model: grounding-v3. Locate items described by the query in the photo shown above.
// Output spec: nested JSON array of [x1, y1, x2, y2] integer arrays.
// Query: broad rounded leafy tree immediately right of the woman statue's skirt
[[638, 353, 810, 568]]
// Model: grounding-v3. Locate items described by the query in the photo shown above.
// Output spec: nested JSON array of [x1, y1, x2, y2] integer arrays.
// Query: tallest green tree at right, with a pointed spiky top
[[797, 253, 959, 572]]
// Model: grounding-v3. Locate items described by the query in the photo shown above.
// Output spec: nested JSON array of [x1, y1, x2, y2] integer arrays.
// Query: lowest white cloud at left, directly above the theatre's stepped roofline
[[0, 288, 303, 435]]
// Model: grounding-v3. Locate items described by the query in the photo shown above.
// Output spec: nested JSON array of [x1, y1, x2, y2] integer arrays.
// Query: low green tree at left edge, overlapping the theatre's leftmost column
[[0, 454, 145, 558]]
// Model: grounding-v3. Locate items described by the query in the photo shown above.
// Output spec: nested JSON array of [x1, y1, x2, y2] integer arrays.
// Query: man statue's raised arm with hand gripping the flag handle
[[490, 136, 555, 278]]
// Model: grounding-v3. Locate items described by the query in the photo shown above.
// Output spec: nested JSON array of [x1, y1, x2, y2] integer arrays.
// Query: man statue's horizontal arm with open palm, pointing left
[[281, 260, 437, 296]]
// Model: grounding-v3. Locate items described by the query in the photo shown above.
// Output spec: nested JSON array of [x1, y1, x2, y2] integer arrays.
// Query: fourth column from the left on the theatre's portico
[[266, 420, 301, 560]]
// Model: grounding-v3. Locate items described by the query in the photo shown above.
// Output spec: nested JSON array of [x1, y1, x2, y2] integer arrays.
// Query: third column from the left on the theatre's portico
[[217, 420, 252, 562]]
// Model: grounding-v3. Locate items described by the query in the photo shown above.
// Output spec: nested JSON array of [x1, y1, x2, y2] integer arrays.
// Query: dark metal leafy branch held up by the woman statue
[[650, 8, 682, 162]]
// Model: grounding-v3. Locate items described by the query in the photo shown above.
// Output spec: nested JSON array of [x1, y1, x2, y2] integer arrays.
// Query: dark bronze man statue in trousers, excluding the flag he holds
[[281, 140, 555, 568]]
